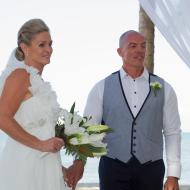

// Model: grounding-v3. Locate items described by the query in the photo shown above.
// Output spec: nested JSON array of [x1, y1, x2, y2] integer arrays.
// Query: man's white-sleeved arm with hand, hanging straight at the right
[[163, 83, 181, 190]]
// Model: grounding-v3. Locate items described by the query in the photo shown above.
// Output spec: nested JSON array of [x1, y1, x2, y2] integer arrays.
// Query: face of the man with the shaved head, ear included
[[118, 33, 146, 69]]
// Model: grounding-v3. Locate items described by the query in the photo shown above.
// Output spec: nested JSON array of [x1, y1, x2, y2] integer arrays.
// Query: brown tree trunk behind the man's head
[[139, 7, 154, 73]]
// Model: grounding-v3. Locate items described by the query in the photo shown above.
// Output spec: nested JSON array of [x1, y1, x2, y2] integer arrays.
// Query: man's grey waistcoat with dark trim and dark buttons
[[102, 72, 164, 163]]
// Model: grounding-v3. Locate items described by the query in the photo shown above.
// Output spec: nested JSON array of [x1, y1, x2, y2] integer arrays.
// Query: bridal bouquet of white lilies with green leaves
[[55, 103, 112, 164]]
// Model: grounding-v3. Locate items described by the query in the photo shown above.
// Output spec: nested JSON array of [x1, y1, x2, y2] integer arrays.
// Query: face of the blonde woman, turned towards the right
[[25, 32, 53, 67]]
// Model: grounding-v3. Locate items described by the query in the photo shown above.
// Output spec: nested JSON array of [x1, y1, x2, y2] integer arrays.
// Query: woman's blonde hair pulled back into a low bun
[[15, 19, 49, 61]]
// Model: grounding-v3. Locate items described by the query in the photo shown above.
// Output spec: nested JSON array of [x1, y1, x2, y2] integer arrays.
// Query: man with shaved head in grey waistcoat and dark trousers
[[84, 31, 181, 190]]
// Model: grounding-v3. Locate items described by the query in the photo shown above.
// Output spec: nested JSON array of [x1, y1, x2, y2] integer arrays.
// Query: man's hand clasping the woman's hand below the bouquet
[[67, 160, 84, 190]]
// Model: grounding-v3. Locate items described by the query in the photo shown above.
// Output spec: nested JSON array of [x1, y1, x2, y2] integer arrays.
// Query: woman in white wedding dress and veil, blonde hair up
[[0, 19, 70, 190]]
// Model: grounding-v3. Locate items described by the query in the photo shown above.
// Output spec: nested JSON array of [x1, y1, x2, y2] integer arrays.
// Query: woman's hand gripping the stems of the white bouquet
[[38, 137, 64, 153]]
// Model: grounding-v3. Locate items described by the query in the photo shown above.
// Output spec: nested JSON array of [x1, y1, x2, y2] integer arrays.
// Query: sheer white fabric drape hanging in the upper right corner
[[139, 0, 190, 68]]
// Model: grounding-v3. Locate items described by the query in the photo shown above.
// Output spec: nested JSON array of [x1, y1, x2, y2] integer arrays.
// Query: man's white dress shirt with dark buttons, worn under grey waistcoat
[[84, 68, 181, 178]]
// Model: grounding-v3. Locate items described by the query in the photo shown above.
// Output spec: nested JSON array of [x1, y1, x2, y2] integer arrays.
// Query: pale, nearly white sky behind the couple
[[0, 0, 190, 131]]
